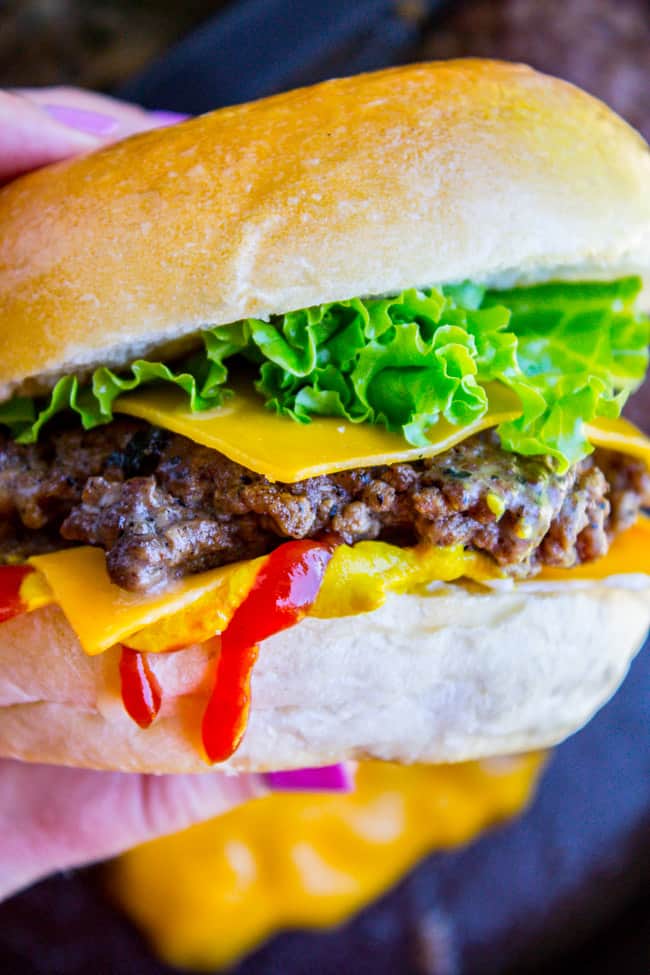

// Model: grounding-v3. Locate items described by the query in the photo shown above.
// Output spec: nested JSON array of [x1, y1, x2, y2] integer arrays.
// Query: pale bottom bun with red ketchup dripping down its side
[[0, 580, 650, 773]]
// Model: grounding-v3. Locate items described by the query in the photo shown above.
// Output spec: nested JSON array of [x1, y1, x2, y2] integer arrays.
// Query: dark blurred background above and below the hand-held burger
[[0, 0, 650, 975]]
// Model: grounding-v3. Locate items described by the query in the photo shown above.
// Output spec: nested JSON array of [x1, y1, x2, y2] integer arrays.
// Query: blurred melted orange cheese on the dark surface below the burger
[[109, 756, 541, 970]]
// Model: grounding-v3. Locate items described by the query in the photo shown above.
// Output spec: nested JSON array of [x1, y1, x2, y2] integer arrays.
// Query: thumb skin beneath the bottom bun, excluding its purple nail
[[0, 760, 267, 900]]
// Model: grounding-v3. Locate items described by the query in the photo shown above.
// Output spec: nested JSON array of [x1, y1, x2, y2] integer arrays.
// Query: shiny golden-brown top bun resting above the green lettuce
[[0, 60, 650, 397]]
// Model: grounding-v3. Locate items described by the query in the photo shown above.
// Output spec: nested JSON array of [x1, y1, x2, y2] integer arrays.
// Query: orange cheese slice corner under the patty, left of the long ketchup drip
[[29, 546, 264, 656]]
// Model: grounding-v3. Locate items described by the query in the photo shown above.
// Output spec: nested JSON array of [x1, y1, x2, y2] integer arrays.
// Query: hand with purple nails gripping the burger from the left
[[0, 88, 266, 900]]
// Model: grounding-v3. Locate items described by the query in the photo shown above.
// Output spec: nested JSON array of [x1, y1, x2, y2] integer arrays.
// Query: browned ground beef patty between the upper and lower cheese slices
[[0, 420, 650, 590]]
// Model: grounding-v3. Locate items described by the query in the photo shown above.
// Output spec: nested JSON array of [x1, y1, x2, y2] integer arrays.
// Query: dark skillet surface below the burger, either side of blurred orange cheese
[[0, 646, 650, 975]]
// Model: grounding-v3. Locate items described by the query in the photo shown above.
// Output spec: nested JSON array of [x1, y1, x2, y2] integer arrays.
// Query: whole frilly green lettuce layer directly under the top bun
[[0, 278, 650, 470]]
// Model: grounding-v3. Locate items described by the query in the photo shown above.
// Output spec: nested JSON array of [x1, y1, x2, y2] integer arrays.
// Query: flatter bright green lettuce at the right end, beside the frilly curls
[[482, 278, 650, 470]]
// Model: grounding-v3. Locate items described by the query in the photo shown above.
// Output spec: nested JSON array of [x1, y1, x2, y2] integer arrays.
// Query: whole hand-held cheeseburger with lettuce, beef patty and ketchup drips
[[0, 60, 650, 773]]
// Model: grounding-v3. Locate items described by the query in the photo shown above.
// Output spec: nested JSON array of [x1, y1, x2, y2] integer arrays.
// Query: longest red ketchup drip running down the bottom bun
[[202, 541, 335, 762]]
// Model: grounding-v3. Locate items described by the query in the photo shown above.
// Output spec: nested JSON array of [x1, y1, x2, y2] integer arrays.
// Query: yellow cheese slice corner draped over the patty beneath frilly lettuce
[[113, 383, 521, 484]]
